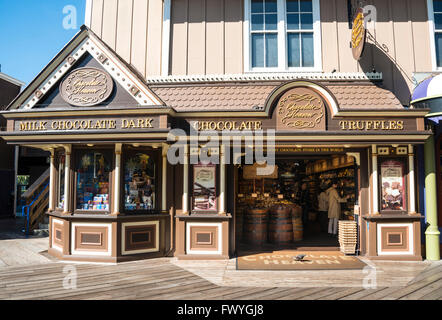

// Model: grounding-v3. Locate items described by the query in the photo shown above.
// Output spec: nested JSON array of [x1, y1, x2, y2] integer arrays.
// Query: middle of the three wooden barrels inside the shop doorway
[[269, 205, 293, 244]]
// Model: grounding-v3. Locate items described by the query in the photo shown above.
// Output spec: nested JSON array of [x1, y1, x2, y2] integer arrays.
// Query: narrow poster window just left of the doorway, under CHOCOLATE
[[193, 164, 217, 211]]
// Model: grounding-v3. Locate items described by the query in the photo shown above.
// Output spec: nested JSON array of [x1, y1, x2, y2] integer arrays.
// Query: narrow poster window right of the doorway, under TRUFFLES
[[380, 160, 406, 211]]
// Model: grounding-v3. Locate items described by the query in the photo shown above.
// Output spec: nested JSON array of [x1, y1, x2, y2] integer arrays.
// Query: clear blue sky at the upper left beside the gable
[[0, 0, 86, 84]]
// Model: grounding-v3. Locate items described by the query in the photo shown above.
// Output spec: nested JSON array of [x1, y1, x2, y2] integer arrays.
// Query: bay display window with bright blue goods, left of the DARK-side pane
[[76, 152, 111, 211]]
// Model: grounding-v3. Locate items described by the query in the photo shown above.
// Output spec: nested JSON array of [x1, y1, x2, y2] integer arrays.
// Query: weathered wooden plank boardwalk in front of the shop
[[0, 258, 442, 300]]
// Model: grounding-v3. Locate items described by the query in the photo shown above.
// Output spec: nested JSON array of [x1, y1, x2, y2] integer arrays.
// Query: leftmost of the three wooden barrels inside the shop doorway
[[243, 208, 268, 245]]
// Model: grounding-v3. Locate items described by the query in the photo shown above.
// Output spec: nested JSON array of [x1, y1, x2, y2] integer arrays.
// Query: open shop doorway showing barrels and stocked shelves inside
[[235, 154, 359, 252]]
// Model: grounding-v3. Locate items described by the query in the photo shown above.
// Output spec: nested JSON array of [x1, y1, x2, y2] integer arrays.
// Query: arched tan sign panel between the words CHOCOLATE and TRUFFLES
[[277, 87, 326, 131]]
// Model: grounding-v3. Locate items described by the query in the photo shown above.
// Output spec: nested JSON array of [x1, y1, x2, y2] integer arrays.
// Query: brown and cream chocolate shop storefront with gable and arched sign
[[1, 29, 431, 262]]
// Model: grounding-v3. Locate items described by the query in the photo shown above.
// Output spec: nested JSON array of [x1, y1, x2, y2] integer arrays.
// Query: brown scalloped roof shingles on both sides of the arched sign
[[150, 82, 403, 112]]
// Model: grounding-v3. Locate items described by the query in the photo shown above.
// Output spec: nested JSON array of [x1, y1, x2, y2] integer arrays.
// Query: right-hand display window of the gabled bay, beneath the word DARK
[[124, 153, 156, 211]]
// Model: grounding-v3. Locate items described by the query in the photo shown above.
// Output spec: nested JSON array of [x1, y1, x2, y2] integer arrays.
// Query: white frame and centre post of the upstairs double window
[[243, 0, 322, 73]]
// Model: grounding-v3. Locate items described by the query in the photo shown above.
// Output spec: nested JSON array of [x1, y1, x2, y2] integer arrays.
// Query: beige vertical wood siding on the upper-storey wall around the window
[[91, 0, 431, 104]]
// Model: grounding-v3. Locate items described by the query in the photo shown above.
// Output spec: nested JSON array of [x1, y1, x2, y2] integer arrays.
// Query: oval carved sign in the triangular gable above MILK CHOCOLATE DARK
[[60, 68, 114, 107]]
